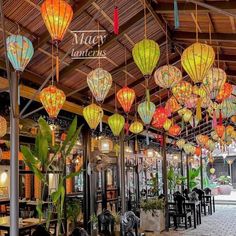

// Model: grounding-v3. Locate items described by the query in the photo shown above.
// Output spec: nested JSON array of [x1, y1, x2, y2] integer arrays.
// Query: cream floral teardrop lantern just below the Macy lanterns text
[[87, 68, 112, 102]]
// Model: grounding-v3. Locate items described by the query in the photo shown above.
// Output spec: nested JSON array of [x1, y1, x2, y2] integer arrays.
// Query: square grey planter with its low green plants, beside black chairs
[[140, 198, 165, 233]]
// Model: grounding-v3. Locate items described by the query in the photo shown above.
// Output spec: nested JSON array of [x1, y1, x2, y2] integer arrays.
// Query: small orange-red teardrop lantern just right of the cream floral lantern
[[116, 87, 135, 113]]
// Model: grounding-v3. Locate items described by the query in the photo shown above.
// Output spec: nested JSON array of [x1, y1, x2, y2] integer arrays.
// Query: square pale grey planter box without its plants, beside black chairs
[[140, 210, 165, 233]]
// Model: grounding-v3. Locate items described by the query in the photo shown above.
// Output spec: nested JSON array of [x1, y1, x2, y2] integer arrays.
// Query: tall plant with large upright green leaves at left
[[21, 117, 82, 235]]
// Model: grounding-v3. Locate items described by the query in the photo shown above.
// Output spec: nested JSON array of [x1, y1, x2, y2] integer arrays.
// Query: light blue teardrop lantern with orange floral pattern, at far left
[[6, 35, 34, 72]]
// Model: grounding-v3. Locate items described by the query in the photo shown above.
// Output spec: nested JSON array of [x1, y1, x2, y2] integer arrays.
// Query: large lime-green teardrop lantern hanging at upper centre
[[132, 39, 160, 76]]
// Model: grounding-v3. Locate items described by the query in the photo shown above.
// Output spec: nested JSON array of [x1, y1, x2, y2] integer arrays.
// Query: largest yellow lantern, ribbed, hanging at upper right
[[181, 42, 215, 83]]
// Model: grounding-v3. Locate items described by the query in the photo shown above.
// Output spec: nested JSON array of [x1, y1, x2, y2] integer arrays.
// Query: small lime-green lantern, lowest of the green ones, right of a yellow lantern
[[108, 113, 125, 136]]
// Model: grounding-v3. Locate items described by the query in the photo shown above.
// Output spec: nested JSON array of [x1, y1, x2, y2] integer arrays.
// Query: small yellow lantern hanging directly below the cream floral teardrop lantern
[[83, 103, 103, 130]]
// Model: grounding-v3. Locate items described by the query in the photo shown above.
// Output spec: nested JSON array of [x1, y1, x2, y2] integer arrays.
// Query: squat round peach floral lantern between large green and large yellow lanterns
[[154, 65, 182, 88]]
